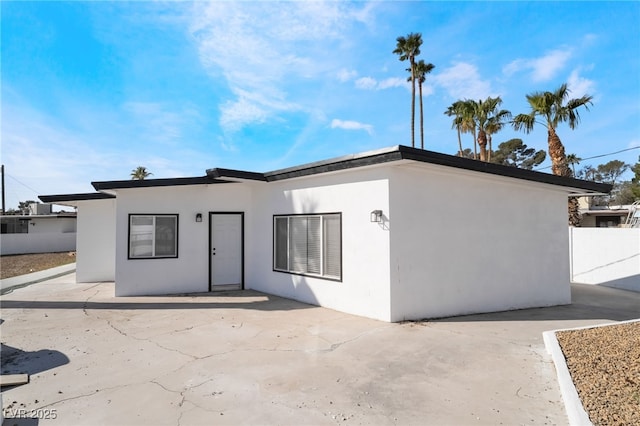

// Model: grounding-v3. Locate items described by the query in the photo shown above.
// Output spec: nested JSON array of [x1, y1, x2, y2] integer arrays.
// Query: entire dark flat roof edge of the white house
[[40, 145, 612, 196]]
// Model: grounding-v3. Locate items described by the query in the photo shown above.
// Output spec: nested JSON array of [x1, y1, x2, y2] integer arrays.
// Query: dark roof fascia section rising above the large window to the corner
[[264, 150, 402, 182]]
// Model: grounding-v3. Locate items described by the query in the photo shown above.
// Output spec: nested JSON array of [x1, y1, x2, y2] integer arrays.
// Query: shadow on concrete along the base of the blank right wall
[[433, 284, 640, 322]]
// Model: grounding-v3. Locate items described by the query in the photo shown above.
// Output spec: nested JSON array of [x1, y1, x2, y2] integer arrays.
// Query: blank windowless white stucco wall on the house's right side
[[389, 164, 571, 321]]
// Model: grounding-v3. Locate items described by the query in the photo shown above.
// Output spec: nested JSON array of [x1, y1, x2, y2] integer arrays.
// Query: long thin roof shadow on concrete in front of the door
[[2, 290, 315, 311]]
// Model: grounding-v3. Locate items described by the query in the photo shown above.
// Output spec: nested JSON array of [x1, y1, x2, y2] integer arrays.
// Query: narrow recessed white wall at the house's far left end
[[76, 199, 116, 282]]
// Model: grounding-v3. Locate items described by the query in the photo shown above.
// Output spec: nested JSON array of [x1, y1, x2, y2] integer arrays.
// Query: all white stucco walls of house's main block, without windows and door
[[104, 161, 571, 321]]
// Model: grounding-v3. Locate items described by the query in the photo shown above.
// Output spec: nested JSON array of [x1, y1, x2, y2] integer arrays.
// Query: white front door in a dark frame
[[209, 213, 243, 289]]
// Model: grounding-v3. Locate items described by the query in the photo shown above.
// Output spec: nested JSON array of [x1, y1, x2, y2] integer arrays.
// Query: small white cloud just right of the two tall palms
[[431, 62, 493, 99]]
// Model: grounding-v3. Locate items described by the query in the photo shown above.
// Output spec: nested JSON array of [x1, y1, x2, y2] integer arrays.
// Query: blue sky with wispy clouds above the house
[[0, 1, 640, 208]]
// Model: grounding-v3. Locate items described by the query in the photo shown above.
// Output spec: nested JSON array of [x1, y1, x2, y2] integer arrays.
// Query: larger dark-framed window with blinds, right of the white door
[[273, 213, 342, 280]]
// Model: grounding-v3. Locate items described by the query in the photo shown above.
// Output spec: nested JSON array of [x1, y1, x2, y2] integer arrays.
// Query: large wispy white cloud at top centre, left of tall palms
[[189, 1, 370, 131]]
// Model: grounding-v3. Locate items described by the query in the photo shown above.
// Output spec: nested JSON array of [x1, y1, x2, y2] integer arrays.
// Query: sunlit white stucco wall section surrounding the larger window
[[247, 168, 389, 321]]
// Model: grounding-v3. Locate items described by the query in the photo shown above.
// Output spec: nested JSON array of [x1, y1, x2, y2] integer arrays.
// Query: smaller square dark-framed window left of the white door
[[129, 214, 178, 259]]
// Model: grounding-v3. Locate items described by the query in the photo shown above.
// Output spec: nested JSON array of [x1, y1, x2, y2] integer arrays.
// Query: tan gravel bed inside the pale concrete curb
[[556, 322, 640, 426]]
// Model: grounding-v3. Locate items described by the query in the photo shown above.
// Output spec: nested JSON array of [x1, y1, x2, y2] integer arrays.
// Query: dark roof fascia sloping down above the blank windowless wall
[[398, 145, 613, 193]]
